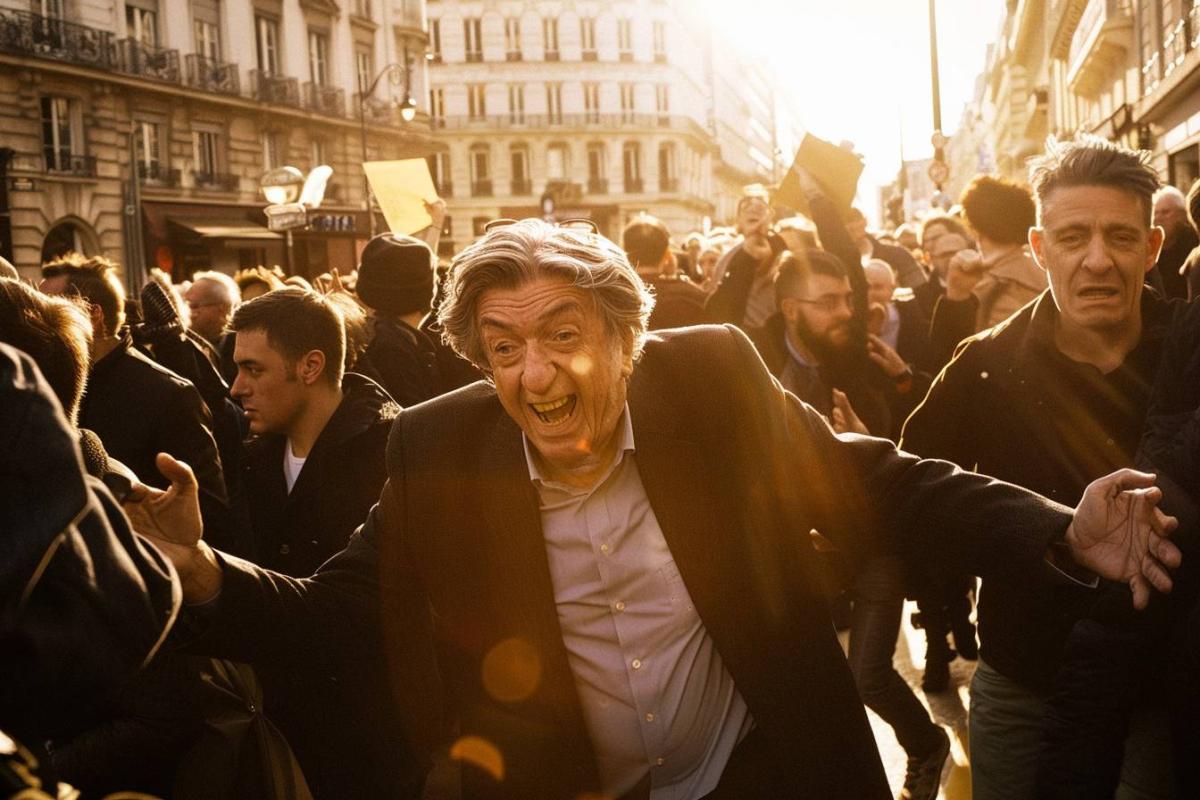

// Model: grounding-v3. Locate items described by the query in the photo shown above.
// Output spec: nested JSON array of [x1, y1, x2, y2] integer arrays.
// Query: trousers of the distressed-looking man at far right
[[970, 658, 1048, 800]]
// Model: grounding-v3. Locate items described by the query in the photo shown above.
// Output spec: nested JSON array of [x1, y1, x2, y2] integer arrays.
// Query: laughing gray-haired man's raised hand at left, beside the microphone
[[124, 453, 221, 603]]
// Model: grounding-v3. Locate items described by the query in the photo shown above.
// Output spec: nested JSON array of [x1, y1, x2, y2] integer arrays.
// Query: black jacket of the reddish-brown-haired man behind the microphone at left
[[79, 332, 239, 549]]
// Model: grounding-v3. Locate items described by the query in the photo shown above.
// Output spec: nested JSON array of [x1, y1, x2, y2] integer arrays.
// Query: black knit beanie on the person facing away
[[355, 233, 433, 317]]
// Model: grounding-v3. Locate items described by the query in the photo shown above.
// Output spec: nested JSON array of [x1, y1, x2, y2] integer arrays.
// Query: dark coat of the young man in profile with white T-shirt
[[242, 373, 415, 800]]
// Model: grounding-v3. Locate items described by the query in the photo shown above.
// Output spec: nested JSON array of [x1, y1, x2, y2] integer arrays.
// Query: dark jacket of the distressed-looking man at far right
[[900, 291, 1183, 690]]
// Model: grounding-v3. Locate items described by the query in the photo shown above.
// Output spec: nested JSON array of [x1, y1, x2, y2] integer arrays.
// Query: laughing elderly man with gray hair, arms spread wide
[[127, 219, 1178, 800]]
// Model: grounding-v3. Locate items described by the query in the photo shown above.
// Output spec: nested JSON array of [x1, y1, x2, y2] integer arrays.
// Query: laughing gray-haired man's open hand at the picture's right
[[1064, 469, 1182, 608]]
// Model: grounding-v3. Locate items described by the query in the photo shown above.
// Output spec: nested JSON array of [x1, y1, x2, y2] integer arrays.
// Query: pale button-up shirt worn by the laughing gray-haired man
[[524, 407, 754, 800]]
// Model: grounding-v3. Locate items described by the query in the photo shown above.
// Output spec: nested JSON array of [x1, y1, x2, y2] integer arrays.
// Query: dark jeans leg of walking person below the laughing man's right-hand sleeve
[[848, 557, 941, 757]]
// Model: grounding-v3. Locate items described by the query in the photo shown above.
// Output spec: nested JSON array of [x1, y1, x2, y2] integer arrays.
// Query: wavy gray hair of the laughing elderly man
[[438, 218, 654, 374]]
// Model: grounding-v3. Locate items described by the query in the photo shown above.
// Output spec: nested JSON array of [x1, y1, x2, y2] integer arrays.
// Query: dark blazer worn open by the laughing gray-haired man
[[192, 325, 1069, 800]]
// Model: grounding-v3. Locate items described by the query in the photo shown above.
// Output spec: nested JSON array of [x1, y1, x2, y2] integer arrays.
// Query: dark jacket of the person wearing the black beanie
[[360, 317, 446, 408]]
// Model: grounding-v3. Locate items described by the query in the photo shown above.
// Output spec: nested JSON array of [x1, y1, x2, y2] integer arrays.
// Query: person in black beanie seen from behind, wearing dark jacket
[[356, 233, 445, 408]]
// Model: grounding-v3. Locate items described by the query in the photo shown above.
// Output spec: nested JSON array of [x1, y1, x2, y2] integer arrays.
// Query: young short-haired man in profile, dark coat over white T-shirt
[[229, 288, 416, 799]]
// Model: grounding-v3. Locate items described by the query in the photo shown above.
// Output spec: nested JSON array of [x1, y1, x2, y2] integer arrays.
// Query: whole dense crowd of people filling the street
[[0, 131, 1200, 800]]
